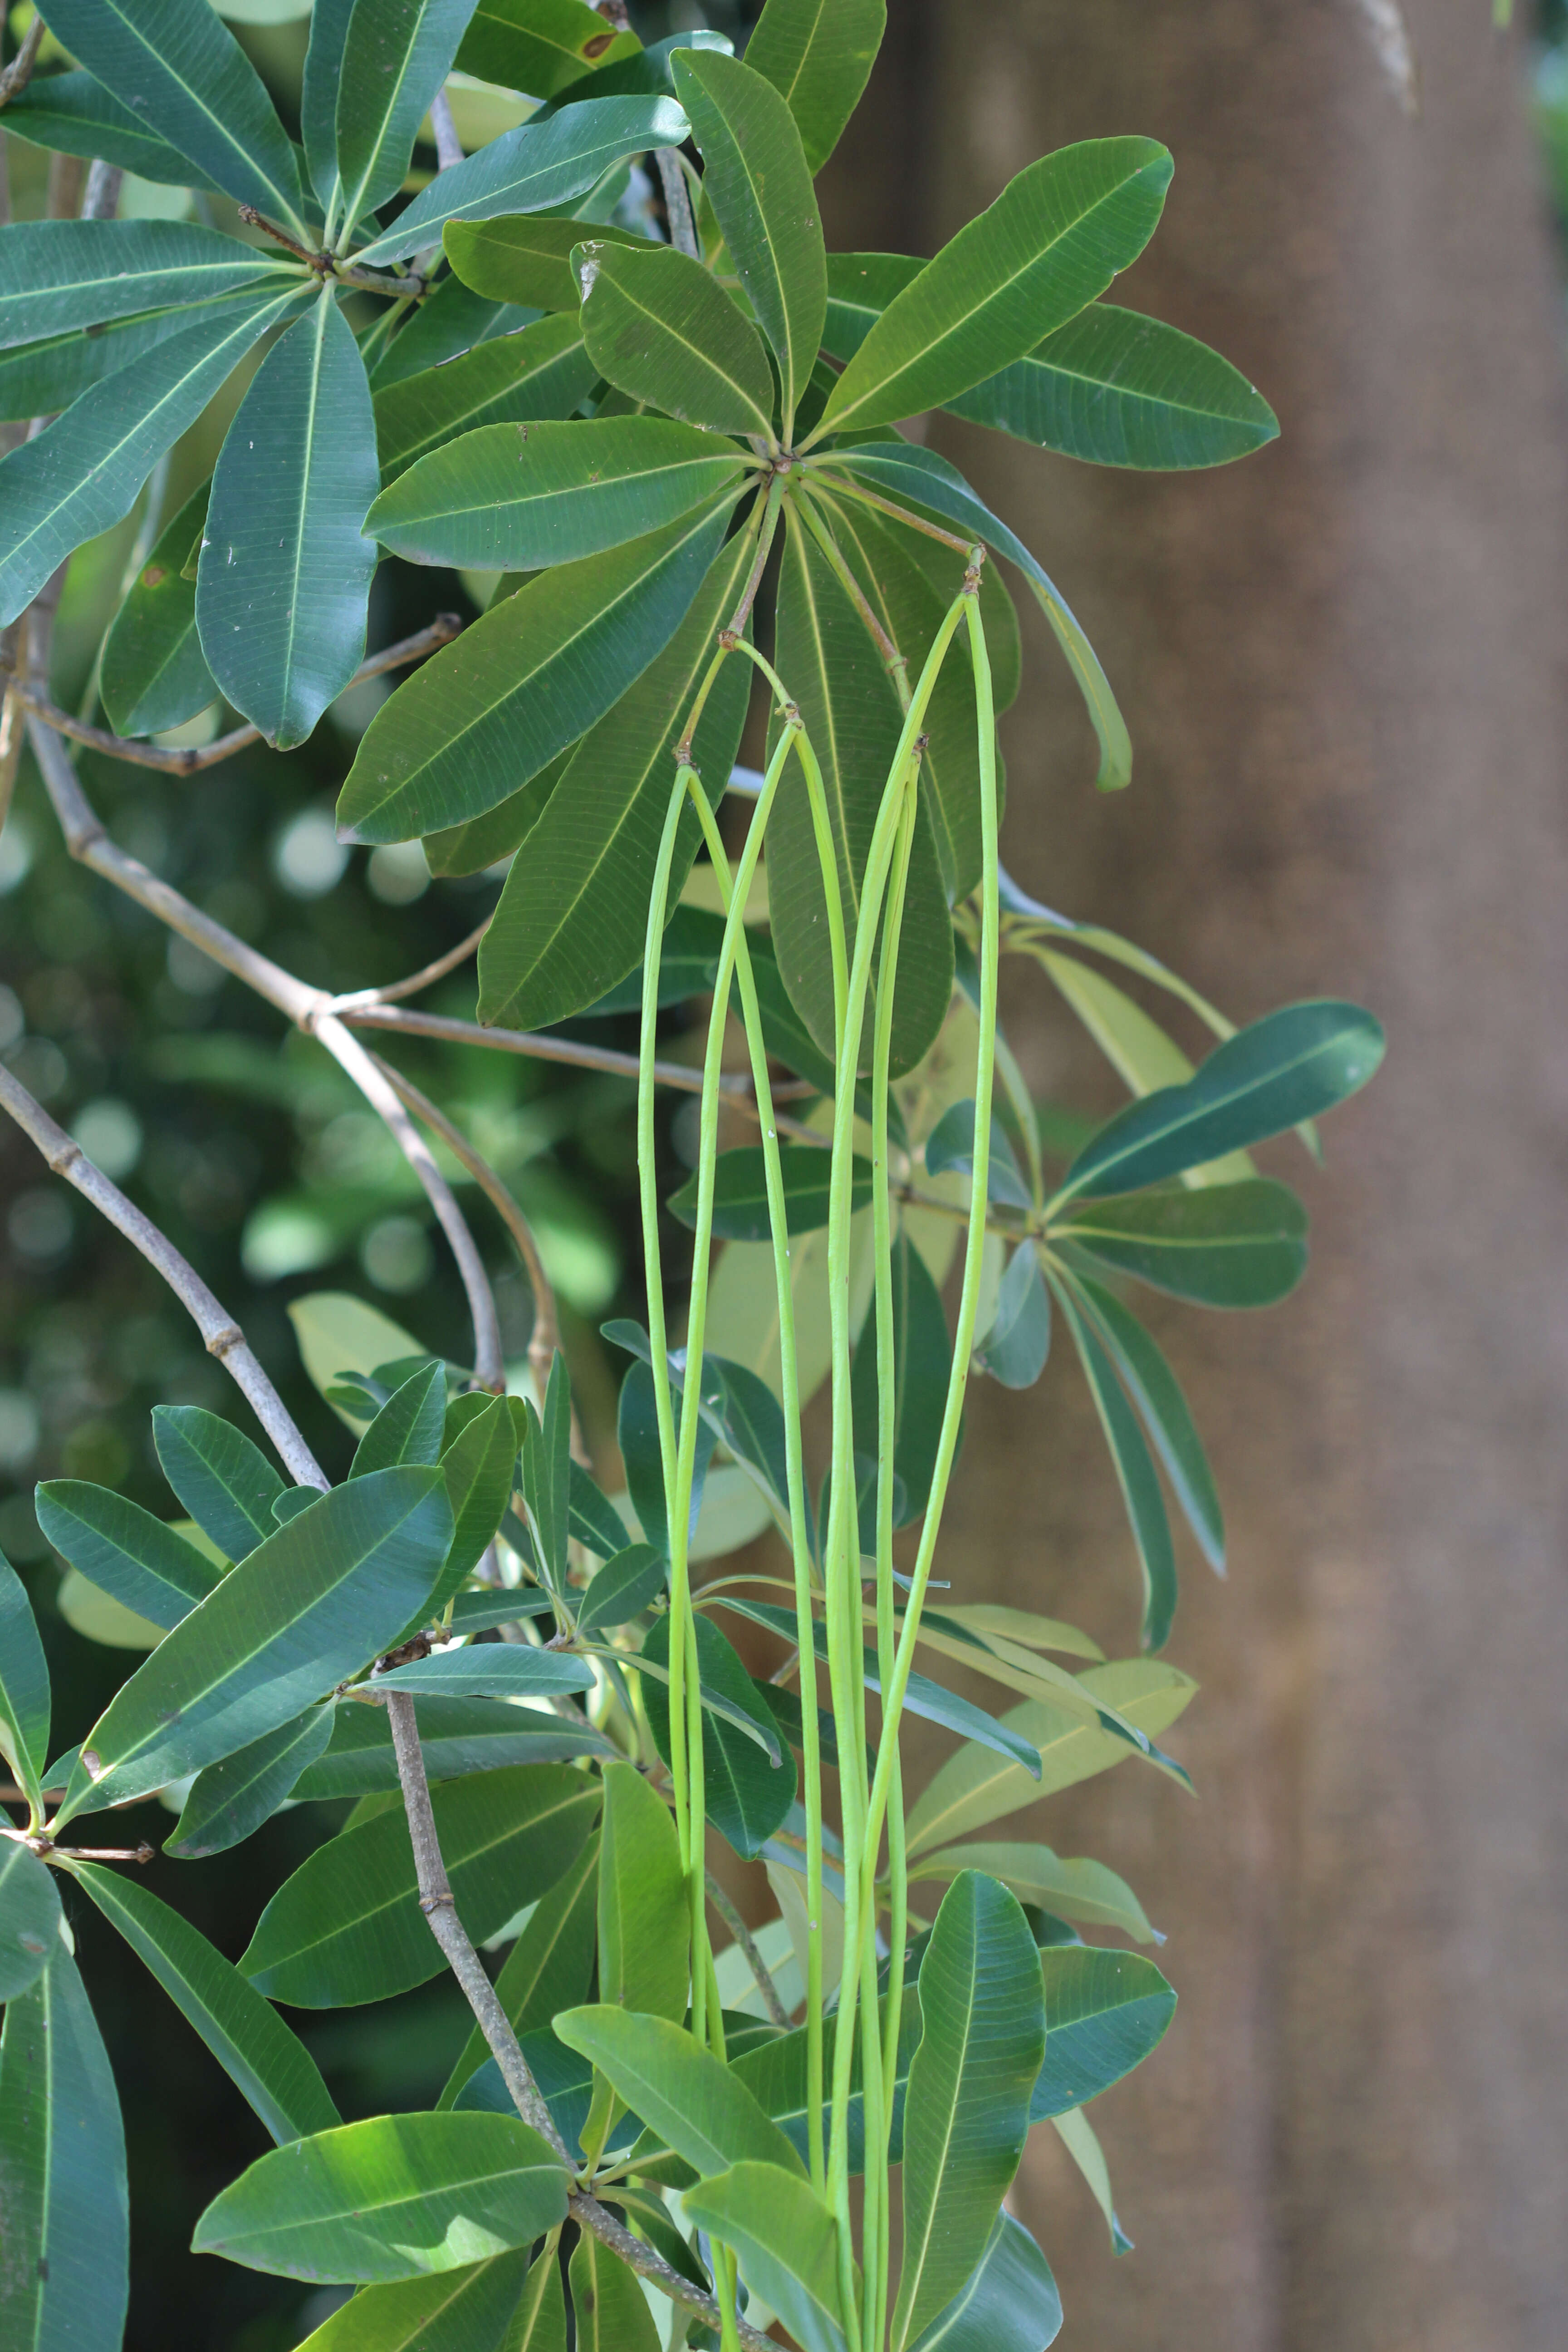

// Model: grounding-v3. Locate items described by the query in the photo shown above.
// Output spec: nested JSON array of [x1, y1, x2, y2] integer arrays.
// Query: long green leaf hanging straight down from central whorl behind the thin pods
[[769, 517, 964, 1077]]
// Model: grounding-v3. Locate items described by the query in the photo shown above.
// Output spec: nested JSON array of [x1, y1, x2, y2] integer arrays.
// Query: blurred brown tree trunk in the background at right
[[828, 0, 1568, 2352]]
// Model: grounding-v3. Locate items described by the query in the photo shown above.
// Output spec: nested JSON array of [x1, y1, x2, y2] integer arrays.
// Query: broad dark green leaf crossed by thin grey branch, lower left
[[240, 1764, 599, 2009]]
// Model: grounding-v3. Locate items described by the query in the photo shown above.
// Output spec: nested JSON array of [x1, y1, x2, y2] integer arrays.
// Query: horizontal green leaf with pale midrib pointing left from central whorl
[[364, 418, 745, 572]]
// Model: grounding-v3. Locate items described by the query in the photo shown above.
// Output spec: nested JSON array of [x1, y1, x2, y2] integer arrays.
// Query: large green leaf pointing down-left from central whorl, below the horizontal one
[[338, 501, 734, 842]]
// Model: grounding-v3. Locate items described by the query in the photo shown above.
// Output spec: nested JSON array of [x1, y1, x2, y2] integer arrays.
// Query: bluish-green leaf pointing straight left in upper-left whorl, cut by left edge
[[0, 221, 277, 348]]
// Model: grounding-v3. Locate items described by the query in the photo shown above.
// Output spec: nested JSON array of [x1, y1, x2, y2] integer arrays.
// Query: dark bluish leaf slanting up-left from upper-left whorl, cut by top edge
[[36, 0, 303, 226]]
